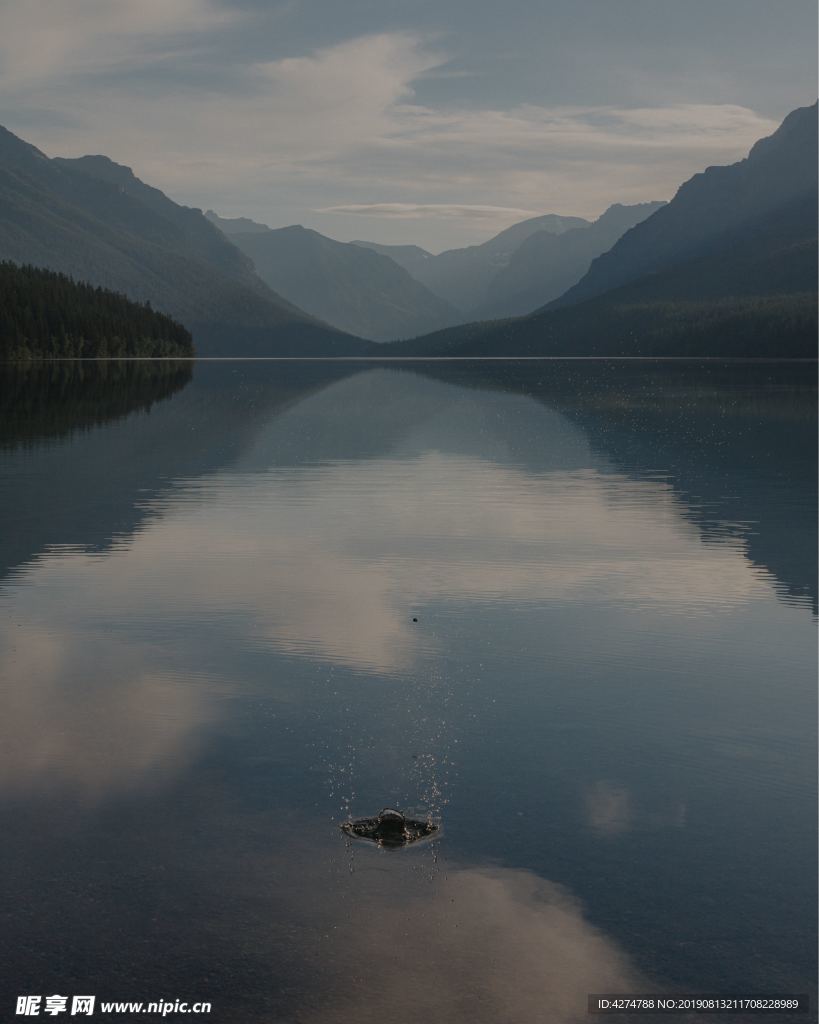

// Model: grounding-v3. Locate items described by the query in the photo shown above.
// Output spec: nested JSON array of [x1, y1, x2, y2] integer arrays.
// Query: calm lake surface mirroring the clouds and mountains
[[0, 361, 817, 1024]]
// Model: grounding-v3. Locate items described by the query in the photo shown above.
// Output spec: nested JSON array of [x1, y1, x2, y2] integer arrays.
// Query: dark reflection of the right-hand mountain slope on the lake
[[413, 360, 819, 610]]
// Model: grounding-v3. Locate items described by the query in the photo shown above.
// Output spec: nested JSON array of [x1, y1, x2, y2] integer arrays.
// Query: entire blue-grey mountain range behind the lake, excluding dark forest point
[[0, 104, 817, 355]]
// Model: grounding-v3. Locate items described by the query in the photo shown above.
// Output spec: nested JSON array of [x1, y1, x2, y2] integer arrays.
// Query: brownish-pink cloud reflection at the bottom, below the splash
[[296, 864, 646, 1024]]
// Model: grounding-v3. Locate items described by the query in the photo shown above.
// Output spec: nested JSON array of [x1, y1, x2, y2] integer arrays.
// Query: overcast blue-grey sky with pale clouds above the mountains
[[0, 0, 817, 252]]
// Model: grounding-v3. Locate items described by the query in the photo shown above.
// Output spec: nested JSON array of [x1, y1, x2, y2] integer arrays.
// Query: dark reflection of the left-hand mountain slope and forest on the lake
[[0, 362, 351, 578]]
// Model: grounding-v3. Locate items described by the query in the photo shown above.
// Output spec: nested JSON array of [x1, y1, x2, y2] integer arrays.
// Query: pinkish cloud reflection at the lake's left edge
[[0, 621, 213, 804]]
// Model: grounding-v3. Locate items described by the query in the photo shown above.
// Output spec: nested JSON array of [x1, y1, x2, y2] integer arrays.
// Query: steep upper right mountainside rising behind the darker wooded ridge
[[559, 103, 817, 305]]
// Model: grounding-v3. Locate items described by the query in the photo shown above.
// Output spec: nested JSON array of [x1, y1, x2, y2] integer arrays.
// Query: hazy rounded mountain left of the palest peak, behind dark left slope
[[208, 212, 460, 341]]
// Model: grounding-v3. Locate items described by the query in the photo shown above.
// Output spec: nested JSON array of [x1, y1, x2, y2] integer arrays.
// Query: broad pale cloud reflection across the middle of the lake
[[7, 453, 772, 673]]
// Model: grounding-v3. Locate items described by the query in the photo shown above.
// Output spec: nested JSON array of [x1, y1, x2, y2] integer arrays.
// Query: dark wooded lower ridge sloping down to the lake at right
[[390, 201, 817, 358]]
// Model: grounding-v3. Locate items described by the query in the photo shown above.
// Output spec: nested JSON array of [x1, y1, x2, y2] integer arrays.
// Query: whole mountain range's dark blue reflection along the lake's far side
[[0, 361, 817, 605]]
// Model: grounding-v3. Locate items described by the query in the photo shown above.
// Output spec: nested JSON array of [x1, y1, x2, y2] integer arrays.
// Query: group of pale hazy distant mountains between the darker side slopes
[[206, 203, 661, 341]]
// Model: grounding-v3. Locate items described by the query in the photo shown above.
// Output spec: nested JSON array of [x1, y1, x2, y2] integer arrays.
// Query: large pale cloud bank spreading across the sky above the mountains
[[0, 16, 775, 246]]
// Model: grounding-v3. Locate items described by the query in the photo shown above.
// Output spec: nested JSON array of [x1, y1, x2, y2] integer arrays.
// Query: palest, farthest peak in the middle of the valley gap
[[370, 213, 589, 313]]
